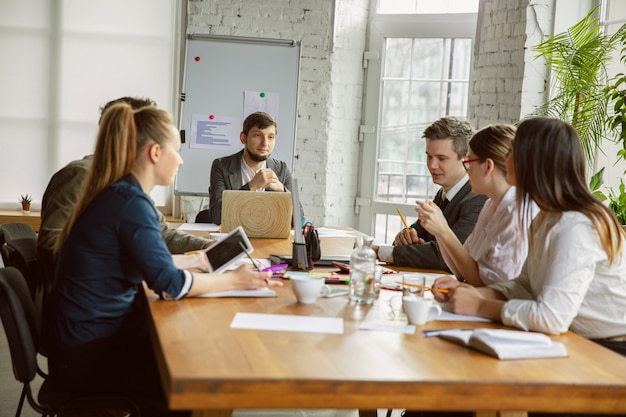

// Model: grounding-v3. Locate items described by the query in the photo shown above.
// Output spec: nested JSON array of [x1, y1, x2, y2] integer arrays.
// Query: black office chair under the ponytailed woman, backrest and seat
[[0, 267, 140, 417]]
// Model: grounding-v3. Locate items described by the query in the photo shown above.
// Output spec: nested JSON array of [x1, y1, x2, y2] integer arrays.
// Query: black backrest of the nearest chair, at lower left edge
[[0, 267, 39, 384]]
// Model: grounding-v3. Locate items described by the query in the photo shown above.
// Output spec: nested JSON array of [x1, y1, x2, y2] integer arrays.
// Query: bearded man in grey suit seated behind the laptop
[[208, 112, 300, 224]]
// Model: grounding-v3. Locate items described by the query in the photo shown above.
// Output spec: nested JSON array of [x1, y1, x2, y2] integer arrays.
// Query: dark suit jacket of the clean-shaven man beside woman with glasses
[[393, 182, 487, 271]]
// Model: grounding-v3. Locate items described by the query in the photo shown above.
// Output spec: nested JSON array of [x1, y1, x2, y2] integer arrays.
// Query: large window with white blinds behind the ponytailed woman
[[0, 0, 180, 210]]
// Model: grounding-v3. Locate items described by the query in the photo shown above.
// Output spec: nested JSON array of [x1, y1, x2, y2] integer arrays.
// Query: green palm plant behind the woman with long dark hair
[[532, 7, 626, 225]]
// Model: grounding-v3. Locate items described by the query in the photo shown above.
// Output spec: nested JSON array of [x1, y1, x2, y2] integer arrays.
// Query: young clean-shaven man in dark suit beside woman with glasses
[[374, 116, 487, 271]]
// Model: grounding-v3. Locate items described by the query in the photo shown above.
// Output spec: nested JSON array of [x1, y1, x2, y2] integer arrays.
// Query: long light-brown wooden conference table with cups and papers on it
[[148, 229, 626, 416]]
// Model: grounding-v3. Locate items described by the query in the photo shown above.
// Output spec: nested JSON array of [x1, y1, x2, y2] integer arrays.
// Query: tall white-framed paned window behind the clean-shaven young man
[[358, 0, 478, 243]]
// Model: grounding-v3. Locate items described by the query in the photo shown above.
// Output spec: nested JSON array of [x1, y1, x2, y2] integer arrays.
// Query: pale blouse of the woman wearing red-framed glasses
[[463, 187, 539, 285]]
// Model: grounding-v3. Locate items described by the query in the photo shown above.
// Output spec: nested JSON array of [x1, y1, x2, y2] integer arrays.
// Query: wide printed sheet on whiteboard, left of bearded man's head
[[189, 114, 241, 152]]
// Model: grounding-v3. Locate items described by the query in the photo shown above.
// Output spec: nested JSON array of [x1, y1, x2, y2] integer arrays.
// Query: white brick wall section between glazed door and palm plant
[[469, 0, 554, 128]]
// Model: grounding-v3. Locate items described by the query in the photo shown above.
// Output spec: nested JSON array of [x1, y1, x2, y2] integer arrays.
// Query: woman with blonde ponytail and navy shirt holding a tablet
[[46, 103, 281, 416]]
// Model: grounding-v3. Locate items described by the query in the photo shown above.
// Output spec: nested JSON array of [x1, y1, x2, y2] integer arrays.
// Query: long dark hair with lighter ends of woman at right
[[513, 117, 624, 262]]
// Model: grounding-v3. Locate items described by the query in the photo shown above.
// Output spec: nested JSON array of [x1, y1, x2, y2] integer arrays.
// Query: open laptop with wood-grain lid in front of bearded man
[[221, 190, 293, 239]]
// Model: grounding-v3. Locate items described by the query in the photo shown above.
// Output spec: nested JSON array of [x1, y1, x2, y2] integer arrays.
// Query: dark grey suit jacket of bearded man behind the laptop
[[209, 149, 304, 224]]
